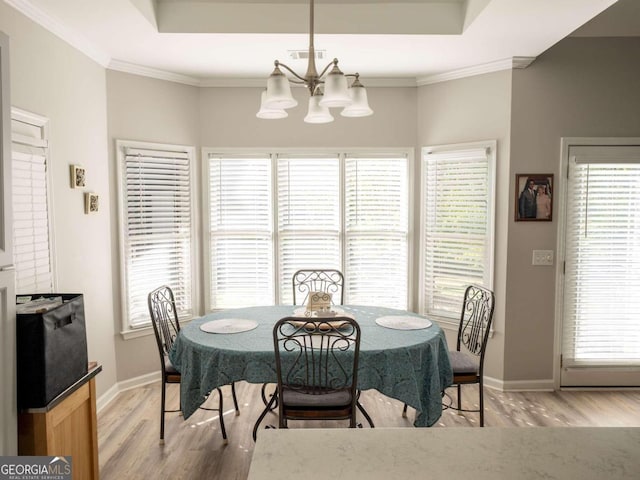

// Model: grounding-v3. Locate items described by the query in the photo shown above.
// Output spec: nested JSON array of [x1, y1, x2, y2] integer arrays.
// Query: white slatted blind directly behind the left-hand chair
[[119, 145, 194, 328]]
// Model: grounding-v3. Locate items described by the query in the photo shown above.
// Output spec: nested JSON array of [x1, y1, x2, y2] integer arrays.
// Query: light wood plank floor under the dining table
[[98, 382, 640, 480]]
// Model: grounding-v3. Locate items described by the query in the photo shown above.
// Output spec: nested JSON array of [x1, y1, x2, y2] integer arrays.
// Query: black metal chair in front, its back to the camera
[[254, 317, 360, 439]]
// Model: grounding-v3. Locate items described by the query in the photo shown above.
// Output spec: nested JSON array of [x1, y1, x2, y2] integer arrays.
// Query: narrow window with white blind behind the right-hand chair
[[420, 142, 495, 322]]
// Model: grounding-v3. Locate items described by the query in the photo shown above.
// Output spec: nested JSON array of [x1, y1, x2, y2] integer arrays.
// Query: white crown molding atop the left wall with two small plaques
[[4, 0, 110, 67]]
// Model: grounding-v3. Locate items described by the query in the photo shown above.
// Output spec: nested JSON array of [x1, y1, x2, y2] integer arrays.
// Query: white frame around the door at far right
[[553, 137, 640, 390]]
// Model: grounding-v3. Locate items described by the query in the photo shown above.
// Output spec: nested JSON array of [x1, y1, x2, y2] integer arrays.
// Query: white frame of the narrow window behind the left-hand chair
[[116, 140, 200, 340]]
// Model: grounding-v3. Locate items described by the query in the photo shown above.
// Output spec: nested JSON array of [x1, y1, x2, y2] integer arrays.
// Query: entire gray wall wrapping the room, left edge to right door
[[6, 3, 640, 394]]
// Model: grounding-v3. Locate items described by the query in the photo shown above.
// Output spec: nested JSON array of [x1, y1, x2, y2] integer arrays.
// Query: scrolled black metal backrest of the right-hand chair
[[457, 285, 495, 362]]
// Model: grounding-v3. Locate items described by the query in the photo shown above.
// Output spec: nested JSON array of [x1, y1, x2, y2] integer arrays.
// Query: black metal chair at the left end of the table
[[147, 285, 240, 445]]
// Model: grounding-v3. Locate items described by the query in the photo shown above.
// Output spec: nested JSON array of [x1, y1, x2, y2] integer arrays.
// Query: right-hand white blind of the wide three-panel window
[[345, 156, 409, 309]]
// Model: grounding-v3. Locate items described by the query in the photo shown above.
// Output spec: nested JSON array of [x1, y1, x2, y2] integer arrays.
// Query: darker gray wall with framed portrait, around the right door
[[504, 37, 640, 382]]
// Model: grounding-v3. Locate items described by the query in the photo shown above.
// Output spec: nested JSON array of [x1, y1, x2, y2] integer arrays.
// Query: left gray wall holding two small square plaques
[[0, 2, 116, 395]]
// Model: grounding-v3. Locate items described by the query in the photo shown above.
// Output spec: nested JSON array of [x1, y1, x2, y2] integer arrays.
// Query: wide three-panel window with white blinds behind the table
[[205, 151, 409, 310]]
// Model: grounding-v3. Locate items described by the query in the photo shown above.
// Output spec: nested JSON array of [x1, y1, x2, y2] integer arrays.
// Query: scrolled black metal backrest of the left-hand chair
[[147, 285, 180, 365]]
